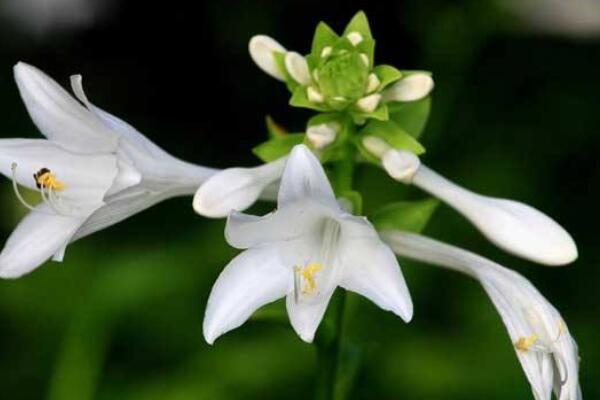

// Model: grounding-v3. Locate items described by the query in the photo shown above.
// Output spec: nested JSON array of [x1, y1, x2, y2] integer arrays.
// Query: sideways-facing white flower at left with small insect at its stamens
[[0, 63, 213, 278]]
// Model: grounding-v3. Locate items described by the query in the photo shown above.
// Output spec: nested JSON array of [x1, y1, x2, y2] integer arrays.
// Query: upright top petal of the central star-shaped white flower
[[277, 145, 339, 209]]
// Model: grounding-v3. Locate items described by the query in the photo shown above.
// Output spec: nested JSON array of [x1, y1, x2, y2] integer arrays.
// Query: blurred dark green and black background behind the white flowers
[[0, 0, 600, 400]]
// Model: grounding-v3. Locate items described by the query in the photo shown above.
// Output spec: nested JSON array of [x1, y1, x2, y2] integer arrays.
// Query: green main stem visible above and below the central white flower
[[315, 152, 360, 400]]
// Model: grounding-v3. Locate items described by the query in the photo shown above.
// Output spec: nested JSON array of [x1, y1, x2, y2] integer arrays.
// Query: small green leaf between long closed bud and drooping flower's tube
[[369, 198, 439, 233]]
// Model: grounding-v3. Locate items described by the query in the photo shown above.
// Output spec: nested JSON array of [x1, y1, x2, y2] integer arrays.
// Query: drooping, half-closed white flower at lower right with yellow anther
[[382, 231, 582, 400]]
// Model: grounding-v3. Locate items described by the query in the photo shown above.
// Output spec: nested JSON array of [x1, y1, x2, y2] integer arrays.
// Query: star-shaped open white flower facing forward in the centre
[[204, 145, 413, 343]]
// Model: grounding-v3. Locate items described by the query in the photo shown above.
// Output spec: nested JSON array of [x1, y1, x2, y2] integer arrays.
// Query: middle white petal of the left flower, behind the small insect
[[0, 139, 117, 208]]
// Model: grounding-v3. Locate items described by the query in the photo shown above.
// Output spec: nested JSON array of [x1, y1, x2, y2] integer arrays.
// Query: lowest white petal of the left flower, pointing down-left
[[0, 204, 85, 278]]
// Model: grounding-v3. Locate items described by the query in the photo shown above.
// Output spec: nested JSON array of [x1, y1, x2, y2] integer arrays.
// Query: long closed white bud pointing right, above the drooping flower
[[413, 165, 577, 265]]
